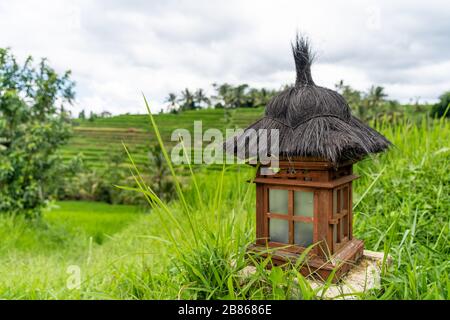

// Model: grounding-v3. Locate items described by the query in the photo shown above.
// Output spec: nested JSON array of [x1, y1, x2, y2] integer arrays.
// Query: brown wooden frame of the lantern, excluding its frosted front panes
[[251, 159, 364, 282]]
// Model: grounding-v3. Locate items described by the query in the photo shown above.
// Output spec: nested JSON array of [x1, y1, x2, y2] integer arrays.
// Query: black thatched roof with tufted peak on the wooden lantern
[[225, 37, 390, 164]]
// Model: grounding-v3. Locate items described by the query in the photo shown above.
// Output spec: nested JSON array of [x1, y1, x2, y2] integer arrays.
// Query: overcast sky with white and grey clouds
[[0, 0, 450, 114]]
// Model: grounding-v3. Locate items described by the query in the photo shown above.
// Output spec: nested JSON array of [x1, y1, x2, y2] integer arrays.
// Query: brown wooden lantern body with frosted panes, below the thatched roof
[[250, 158, 364, 279]]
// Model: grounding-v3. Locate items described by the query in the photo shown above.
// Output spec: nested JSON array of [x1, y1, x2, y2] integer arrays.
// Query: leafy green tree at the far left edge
[[0, 49, 74, 216]]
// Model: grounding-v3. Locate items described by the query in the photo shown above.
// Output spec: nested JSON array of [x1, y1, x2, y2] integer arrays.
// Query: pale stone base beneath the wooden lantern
[[241, 250, 392, 300]]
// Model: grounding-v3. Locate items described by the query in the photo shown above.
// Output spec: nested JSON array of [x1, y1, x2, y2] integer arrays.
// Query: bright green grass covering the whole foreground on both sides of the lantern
[[0, 111, 450, 299]]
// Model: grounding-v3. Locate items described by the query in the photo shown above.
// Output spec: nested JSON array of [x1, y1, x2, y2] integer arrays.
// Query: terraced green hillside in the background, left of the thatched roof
[[61, 108, 264, 168]]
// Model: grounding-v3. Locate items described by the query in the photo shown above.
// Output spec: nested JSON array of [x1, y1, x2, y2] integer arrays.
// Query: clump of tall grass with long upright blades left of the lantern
[[114, 97, 322, 299]]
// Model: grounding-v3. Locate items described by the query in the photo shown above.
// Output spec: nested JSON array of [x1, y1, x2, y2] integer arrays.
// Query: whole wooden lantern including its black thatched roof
[[225, 38, 390, 280]]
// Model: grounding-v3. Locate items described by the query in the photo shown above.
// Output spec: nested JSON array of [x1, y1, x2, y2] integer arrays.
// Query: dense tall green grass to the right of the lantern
[[354, 118, 450, 299]]
